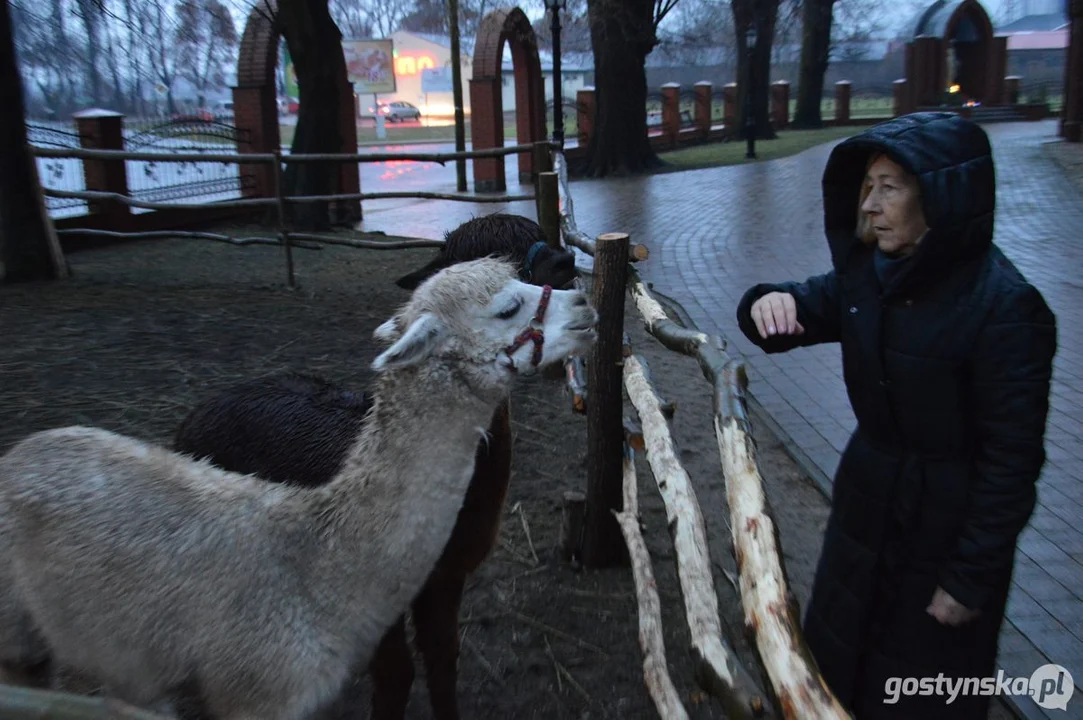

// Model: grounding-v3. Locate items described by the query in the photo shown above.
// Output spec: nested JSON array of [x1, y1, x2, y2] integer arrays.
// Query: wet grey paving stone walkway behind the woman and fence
[[365, 121, 1083, 718]]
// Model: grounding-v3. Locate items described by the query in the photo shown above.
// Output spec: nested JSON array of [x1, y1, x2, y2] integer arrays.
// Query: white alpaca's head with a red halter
[[373, 258, 598, 394]]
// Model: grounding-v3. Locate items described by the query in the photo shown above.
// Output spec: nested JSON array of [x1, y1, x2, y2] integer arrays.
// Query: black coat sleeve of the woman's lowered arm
[[939, 284, 1057, 610]]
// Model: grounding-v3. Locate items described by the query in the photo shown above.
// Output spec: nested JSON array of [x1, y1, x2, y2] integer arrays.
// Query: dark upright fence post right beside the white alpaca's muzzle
[[582, 233, 630, 567]]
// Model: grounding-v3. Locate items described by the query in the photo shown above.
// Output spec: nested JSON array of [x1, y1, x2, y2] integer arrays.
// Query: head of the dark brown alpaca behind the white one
[[395, 212, 578, 290]]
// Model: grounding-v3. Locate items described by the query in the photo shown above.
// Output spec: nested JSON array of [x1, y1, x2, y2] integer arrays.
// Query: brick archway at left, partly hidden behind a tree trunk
[[233, 0, 361, 221]]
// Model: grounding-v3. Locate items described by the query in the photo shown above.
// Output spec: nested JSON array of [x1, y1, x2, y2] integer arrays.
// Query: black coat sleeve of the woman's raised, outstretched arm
[[738, 271, 841, 353]]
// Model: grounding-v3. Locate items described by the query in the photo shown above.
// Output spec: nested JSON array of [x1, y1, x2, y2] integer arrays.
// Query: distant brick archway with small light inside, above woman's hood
[[906, 0, 1007, 112]]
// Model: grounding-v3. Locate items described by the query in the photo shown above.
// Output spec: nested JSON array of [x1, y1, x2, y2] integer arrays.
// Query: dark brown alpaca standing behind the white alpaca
[[168, 214, 575, 720]]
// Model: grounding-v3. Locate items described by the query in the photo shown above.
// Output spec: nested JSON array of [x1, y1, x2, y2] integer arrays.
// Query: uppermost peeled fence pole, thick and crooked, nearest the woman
[[629, 270, 850, 720]]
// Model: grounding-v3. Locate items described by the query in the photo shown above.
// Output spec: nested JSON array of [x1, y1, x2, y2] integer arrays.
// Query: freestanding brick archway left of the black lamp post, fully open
[[470, 8, 546, 192]]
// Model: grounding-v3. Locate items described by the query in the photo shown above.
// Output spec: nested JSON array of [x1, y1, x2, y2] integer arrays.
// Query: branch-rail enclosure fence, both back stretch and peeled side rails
[[8, 137, 849, 720]]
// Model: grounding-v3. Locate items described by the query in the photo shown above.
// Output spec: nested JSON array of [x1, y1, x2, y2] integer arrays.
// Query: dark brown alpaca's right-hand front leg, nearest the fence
[[414, 573, 466, 720]]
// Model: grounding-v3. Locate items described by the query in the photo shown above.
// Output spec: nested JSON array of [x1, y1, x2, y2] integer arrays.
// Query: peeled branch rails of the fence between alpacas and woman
[[553, 150, 850, 720]]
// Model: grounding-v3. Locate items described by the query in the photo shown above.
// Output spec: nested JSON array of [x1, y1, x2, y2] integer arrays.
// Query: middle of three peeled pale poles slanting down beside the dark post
[[624, 355, 767, 719]]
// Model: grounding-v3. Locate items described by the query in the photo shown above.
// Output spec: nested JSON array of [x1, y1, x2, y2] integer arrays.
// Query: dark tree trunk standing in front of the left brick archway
[[278, 0, 347, 230]]
